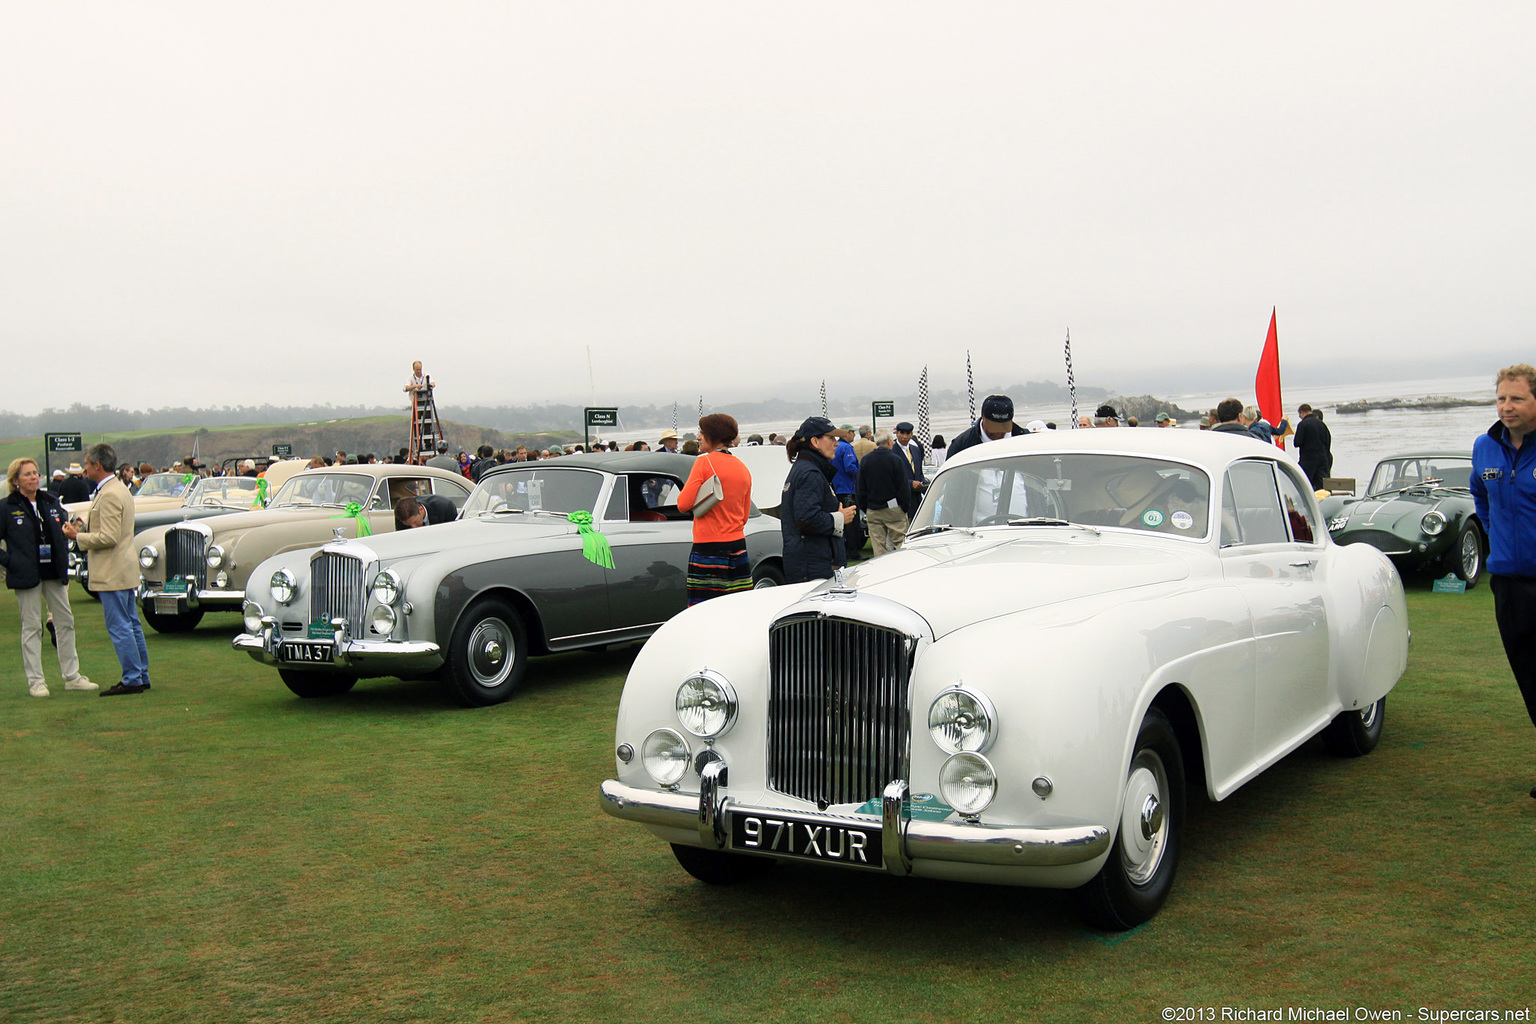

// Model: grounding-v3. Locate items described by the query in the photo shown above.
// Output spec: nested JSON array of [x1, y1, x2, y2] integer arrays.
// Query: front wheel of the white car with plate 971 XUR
[[1078, 708, 1184, 932]]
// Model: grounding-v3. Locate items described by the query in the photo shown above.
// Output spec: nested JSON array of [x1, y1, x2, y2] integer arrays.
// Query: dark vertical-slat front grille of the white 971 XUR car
[[768, 616, 915, 808]]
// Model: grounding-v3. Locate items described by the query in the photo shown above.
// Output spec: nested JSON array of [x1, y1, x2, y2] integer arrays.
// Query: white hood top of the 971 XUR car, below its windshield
[[806, 527, 1193, 637]]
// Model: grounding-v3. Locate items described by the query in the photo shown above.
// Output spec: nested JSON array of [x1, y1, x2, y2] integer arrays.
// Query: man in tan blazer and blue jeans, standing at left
[[65, 444, 149, 697]]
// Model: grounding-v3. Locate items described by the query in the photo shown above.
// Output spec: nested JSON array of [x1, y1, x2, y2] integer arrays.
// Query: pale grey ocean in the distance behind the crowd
[[604, 373, 1496, 485]]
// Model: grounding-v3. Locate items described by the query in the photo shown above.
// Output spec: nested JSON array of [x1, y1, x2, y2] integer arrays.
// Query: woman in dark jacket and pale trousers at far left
[[0, 459, 97, 697]]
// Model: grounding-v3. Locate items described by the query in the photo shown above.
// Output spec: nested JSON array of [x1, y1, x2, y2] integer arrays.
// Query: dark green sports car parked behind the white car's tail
[[1318, 451, 1488, 588]]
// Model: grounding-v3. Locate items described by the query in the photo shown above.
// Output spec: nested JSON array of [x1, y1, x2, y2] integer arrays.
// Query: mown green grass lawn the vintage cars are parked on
[[0, 586, 1536, 1022]]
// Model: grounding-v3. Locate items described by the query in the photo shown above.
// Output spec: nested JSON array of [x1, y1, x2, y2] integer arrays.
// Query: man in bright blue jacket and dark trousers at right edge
[[1471, 362, 1536, 797]]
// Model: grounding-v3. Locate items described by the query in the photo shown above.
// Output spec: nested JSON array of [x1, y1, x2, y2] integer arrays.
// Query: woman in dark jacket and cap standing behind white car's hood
[[779, 416, 859, 583]]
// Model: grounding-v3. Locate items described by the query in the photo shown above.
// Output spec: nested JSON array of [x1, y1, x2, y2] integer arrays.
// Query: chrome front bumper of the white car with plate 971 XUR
[[598, 776, 1111, 875]]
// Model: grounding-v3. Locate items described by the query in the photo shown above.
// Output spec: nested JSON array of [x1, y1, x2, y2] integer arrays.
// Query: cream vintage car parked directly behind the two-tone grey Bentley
[[134, 465, 470, 633]]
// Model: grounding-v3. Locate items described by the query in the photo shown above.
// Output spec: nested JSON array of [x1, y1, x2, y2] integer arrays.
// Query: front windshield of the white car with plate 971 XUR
[[911, 454, 1210, 539]]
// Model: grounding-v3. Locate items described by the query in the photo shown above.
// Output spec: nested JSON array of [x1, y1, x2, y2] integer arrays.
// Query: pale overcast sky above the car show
[[0, 0, 1536, 413]]
